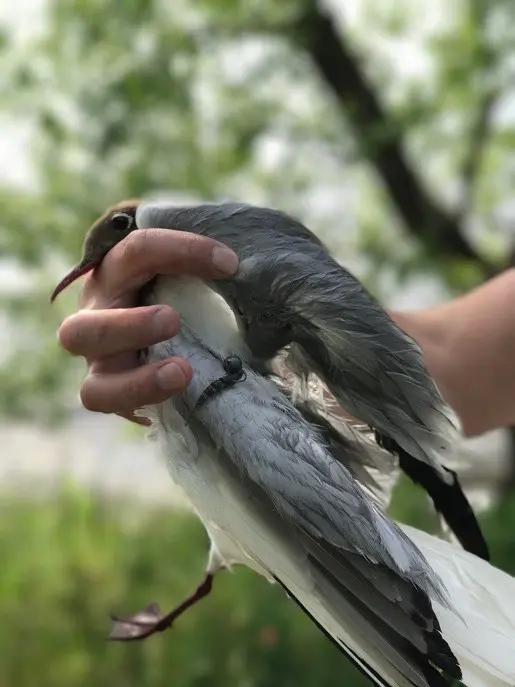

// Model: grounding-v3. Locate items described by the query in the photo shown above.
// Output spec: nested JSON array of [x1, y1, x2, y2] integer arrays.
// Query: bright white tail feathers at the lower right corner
[[400, 525, 515, 687]]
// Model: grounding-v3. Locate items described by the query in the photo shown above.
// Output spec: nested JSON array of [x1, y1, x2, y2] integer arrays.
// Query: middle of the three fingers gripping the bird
[[58, 306, 180, 360]]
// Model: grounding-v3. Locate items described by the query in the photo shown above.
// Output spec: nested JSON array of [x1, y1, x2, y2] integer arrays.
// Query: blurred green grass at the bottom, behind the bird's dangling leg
[[0, 487, 515, 687]]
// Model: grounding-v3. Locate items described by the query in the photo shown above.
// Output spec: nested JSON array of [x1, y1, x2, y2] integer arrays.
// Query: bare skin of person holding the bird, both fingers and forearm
[[58, 229, 515, 436]]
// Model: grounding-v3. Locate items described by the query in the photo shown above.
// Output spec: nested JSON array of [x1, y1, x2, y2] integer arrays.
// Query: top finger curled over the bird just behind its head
[[82, 229, 238, 308]]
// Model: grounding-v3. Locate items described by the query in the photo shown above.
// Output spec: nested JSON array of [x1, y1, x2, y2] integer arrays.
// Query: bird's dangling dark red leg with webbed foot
[[109, 572, 214, 642]]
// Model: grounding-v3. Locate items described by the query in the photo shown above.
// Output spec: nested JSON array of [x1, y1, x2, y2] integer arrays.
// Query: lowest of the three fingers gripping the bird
[[80, 358, 193, 419]]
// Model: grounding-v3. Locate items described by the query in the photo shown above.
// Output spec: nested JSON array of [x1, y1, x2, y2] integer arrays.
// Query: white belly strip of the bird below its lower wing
[[140, 399, 427, 687]]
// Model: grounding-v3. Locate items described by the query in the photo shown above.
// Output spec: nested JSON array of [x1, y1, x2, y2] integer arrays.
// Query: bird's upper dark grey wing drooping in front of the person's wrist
[[249, 242, 458, 478]]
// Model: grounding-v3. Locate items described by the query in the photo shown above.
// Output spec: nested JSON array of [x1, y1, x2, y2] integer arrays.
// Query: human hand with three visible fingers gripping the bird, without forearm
[[58, 229, 238, 424]]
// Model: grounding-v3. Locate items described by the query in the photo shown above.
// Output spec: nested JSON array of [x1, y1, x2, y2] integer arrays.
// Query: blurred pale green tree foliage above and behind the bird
[[0, 0, 515, 421]]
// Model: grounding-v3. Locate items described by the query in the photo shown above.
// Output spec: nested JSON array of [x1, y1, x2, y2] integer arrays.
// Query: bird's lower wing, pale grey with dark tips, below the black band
[[224, 390, 460, 687]]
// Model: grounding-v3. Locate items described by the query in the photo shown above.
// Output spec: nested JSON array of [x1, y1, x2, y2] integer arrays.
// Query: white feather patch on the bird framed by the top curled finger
[[150, 276, 250, 360]]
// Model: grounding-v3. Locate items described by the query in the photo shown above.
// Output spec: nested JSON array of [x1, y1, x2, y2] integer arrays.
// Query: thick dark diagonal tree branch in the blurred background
[[297, 0, 496, 277]]
